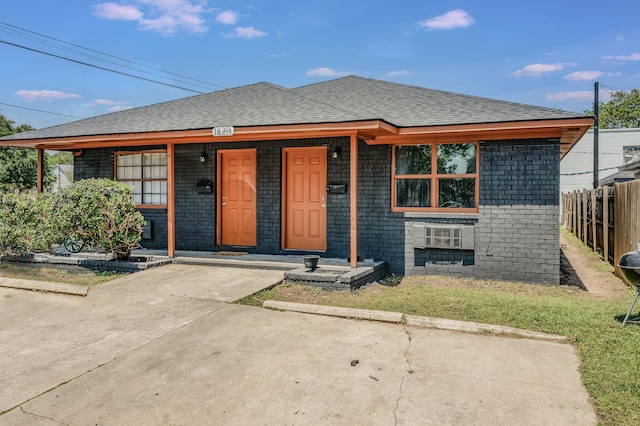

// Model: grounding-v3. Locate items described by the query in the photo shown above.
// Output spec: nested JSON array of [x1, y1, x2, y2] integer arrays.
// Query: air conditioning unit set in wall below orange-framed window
[[412, 224, 475, 250]]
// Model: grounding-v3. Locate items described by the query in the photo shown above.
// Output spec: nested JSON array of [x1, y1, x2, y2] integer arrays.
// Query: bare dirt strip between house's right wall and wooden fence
[[560, 232, 628, 298]]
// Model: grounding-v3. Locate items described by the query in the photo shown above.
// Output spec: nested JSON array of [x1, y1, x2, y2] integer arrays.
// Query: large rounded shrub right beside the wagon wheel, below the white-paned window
[[51, 179, 144, 259]]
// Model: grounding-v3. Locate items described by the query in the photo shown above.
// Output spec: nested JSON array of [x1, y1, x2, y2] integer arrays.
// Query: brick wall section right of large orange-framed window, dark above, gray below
[[475, 139, 560, 284]]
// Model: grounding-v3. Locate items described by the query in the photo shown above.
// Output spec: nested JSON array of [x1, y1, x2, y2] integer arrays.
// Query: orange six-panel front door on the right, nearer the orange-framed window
[[282, 147, 327, 251]]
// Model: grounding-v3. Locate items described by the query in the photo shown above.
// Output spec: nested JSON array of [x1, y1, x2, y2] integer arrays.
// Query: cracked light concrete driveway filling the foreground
[[0, 265, 596, 425]]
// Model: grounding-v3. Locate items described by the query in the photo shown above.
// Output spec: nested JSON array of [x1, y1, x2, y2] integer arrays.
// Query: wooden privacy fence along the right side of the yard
[[562, 180, 640, 276]]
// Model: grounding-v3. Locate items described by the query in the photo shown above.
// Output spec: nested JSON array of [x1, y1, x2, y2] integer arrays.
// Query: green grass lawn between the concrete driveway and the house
[[240, 276, 640, 425]]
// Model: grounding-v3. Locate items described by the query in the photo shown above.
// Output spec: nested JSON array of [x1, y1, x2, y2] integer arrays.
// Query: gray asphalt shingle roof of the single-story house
[[2, 76, 585, 140]]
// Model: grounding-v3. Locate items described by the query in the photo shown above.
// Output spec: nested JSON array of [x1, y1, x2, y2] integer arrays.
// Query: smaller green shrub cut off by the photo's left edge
[[0, 194, 54, 256]]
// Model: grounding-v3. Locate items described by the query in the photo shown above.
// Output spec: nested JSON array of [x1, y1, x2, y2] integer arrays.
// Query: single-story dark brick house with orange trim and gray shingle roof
[[0, 76, 593, 284]]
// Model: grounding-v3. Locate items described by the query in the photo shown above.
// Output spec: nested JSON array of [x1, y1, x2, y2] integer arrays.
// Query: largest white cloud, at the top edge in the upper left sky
[[94, 0, 208, 35]]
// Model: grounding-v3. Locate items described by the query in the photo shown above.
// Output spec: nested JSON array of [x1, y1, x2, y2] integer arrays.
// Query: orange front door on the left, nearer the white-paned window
[[218, 149, 256, 246]]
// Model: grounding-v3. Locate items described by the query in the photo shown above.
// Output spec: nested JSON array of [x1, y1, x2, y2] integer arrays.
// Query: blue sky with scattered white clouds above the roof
[[0, 0, 640, 128]]
